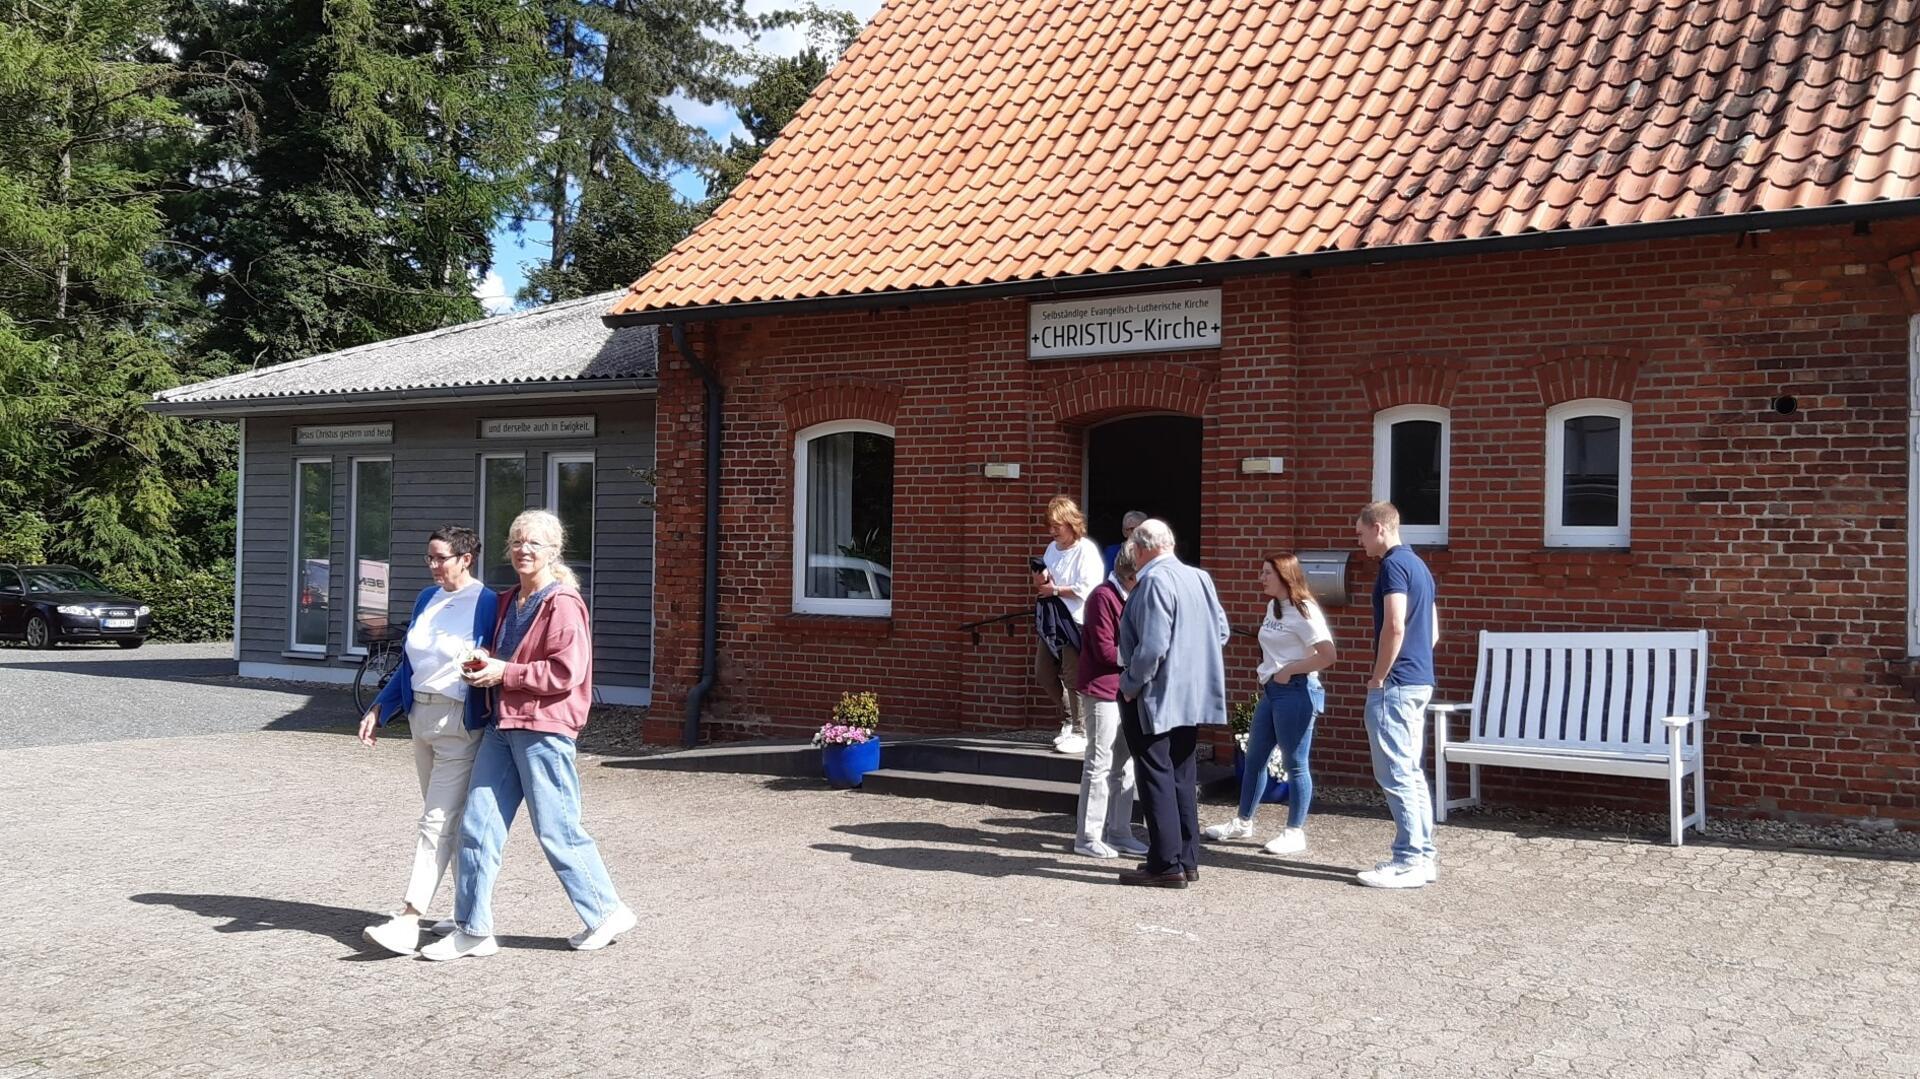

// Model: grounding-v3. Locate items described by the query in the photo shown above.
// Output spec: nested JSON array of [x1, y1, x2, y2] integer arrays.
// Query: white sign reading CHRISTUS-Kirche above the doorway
[[1027, 288, 1219, 359]]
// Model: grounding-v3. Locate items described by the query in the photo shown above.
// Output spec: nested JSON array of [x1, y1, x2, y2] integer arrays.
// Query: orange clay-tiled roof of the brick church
[[611, 0, 1920, 321]]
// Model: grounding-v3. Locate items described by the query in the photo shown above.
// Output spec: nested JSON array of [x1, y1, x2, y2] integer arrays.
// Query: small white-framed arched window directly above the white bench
[[1546, 397, 1634, 547]]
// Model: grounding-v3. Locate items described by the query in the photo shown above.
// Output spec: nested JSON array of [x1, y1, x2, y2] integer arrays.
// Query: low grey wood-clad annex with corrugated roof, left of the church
[[150, 294, 659, 705]]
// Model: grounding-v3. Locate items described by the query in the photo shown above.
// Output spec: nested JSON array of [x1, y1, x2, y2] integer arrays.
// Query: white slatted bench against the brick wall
[[1427, 630, 1707, 847]]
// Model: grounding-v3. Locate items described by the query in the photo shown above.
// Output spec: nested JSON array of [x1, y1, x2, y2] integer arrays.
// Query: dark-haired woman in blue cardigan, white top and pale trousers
[[359, 524, 499, 956]]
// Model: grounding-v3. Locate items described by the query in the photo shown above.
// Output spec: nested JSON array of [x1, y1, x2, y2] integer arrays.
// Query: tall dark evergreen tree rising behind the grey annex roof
[[169, 0, 549, 367]]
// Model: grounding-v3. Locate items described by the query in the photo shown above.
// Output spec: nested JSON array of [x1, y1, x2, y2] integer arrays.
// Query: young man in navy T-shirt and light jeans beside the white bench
[[1356, 501, 1440, 887]]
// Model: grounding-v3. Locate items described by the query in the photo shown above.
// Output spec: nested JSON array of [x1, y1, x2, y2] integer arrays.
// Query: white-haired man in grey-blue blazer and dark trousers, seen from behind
[[1119, 520, 1231, 887]]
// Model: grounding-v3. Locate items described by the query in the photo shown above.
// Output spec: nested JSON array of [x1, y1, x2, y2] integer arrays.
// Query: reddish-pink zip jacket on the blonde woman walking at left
[[493, 584, 593, 737]]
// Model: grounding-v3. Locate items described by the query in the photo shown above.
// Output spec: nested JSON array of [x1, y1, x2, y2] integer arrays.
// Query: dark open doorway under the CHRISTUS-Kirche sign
[[1087, 417, 1200, 564]]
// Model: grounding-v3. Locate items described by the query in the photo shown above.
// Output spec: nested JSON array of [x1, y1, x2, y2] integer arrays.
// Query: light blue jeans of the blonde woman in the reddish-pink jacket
[[453, 728, 620, 937]]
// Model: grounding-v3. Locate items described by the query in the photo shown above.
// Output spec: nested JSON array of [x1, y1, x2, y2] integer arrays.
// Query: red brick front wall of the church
[[653, 223, 1920, 824]]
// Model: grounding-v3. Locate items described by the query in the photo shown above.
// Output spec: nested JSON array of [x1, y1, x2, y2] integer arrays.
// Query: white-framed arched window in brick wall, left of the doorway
[[793, 420, 893, 616]]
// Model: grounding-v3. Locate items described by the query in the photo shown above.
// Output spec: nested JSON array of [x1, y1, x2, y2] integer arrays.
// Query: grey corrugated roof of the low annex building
[[154, 292, 659, 415]]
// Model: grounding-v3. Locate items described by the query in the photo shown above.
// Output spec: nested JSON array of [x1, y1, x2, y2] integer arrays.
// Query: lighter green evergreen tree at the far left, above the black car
[[0, 0, 230, 570]]
